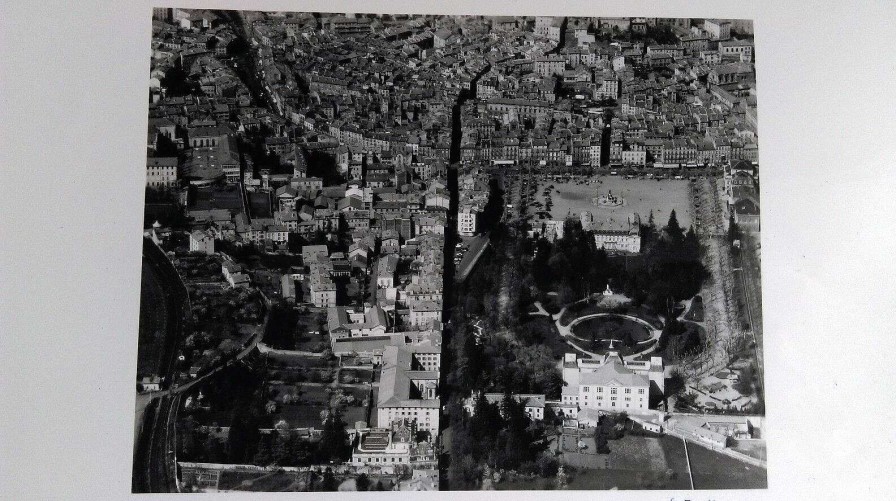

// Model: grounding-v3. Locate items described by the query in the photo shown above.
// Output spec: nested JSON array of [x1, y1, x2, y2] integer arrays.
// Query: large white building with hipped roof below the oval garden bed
[[559, 352, 664, 417]]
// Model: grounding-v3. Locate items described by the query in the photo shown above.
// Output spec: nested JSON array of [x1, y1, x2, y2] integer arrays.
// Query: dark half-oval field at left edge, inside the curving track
[[137, 263, 167, 375]]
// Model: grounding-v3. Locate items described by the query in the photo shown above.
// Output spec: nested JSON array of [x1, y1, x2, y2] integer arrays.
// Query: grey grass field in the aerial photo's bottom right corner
[[688, 444, 768, 489]]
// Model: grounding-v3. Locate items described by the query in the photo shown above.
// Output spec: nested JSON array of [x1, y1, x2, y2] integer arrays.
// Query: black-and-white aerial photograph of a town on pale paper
[[132, 8, 767, 492]]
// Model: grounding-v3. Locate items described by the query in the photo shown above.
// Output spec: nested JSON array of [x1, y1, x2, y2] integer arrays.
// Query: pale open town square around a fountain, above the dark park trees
[[532, 176, 693, 228]]
